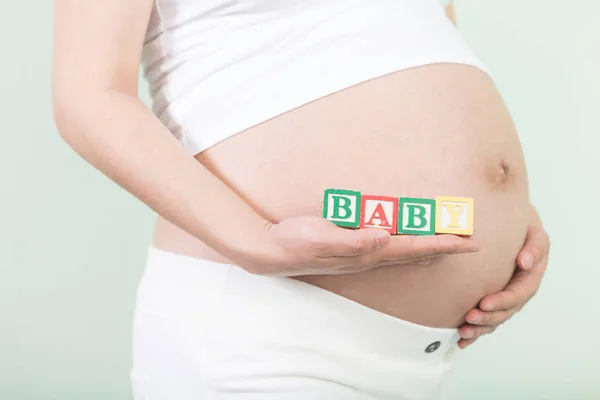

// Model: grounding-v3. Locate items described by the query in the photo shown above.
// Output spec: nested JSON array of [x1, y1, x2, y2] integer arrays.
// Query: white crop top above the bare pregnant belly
[[142, 0, 487, 155]]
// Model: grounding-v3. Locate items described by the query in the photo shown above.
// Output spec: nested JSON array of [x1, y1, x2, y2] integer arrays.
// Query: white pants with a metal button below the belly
[[131, 246, 459, 400]]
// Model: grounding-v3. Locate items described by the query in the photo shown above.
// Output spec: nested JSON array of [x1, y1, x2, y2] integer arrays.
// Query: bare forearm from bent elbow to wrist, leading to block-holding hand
[[55, 90, 274, 261]]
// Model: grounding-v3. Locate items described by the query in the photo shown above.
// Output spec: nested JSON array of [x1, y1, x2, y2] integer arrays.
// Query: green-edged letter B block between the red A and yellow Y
[[398, 197, 436, 235]]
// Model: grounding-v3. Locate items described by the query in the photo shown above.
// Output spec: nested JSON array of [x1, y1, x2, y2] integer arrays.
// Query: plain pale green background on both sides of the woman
[[0, 0, 600, 400]]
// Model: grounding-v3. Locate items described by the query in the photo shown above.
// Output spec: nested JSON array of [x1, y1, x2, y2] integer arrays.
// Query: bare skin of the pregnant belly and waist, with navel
[[154, 64, 529, 327]]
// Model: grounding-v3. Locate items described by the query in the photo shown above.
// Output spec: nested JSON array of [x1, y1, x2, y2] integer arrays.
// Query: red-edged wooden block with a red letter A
[[360, 195, 398, 235]]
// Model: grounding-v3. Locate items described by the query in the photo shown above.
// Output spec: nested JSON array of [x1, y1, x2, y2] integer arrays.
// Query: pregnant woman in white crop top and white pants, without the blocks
[[53, 0, 549, 400]]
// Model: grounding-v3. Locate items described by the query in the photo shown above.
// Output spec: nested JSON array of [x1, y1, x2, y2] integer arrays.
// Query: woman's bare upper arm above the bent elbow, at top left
[[52, 0, 154, 102]]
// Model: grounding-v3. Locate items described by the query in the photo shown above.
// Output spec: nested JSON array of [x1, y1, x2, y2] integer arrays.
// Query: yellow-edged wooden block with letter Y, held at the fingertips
[[435, 196, 473, 236]]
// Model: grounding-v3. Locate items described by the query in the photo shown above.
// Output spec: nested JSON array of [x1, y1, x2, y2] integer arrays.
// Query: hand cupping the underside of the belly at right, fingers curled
[[458, 206, 550, 349]]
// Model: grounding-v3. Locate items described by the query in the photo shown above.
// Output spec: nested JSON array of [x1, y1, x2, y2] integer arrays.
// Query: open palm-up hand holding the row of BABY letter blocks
[[241, 216, 478, 276]]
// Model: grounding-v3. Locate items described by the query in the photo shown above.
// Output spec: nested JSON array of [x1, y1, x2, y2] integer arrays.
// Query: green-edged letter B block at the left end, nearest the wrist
[[323, 189, 361, 228]]
